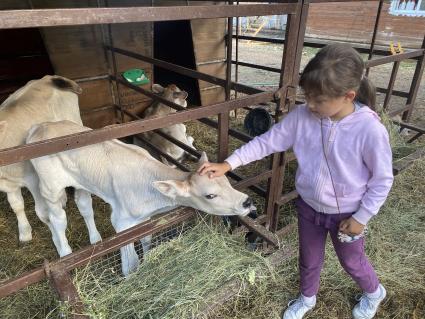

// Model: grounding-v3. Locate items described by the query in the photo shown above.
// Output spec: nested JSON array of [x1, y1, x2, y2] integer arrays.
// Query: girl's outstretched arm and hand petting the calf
[[198, 107, 299, 178]]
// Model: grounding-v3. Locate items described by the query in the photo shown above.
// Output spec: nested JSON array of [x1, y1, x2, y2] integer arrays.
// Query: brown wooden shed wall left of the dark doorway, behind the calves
[[32, 0, 152, 128]]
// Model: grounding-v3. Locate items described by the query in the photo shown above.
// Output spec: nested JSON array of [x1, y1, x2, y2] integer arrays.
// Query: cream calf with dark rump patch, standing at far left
[[0, 75, 99, 242]]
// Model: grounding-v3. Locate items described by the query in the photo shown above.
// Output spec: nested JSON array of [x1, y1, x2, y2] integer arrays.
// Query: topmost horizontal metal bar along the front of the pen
[[0, 3, 296, 29]]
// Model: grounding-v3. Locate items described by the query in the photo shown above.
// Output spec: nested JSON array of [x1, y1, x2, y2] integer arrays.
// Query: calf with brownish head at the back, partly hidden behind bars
[[134, 84, 194, 166]]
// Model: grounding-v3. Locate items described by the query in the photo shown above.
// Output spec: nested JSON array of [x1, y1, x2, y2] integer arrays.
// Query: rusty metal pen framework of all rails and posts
[[0, 0, 425, 318]]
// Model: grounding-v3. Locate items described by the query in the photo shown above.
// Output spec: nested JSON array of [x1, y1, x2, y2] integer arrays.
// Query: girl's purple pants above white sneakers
[[296, 198, 379, 297]]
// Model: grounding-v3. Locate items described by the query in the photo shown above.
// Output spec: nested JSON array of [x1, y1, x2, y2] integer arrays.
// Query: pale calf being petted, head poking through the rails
[[27, 121, 252, 275]]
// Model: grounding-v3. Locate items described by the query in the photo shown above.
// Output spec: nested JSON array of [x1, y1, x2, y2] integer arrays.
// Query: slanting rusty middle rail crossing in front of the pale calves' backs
[[0, 92, 274, 166]]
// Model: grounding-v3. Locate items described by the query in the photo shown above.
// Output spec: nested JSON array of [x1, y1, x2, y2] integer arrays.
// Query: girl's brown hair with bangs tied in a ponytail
[[300, 43, 376, 110]]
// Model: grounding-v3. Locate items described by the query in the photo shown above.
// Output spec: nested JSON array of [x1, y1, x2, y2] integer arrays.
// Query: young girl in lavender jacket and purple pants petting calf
[[199, 44, 393, 319]]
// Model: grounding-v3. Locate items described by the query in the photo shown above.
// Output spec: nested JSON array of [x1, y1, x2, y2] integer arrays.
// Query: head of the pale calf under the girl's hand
[[153, 153, 253, 216]]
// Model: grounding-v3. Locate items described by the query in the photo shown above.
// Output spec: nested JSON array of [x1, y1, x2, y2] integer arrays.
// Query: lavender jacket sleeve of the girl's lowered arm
[[353, 123, 394, 225]]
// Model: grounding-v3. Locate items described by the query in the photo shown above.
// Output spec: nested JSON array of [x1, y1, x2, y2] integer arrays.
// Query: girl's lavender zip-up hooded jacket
[[226, 105, 394, 225]]
